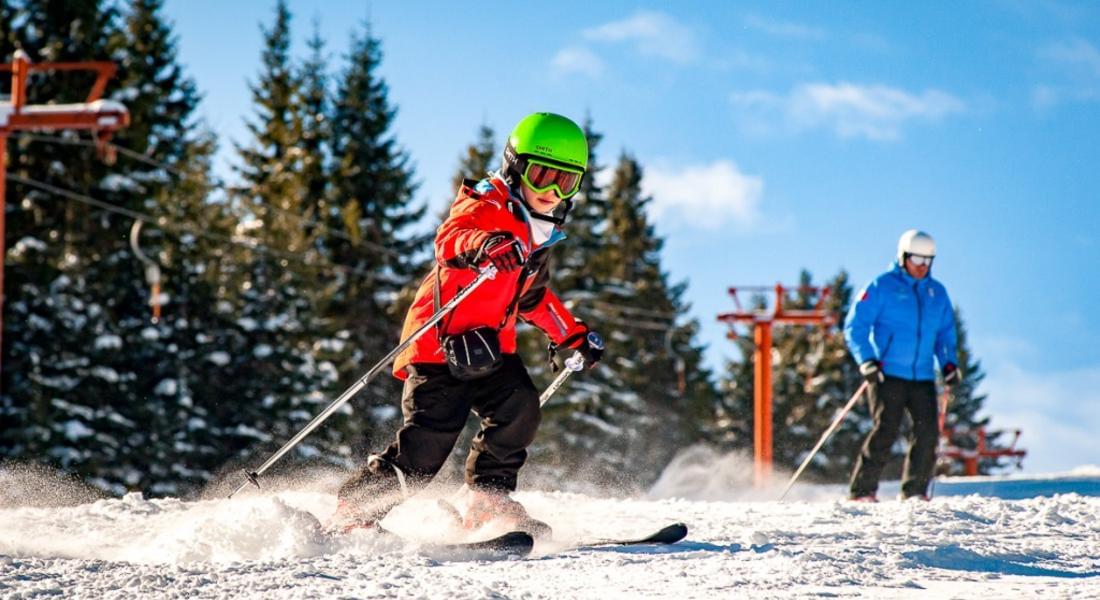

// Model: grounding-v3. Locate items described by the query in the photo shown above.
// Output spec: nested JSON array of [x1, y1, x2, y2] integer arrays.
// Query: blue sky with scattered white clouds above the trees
[[166, 0, 1100, 472]]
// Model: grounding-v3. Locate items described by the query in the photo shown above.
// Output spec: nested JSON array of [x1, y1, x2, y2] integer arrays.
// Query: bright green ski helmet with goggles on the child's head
[[503, 112, 589, 217]]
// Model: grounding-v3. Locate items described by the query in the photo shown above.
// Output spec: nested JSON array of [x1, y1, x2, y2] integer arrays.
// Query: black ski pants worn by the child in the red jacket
[[339, 354, 542, 511]]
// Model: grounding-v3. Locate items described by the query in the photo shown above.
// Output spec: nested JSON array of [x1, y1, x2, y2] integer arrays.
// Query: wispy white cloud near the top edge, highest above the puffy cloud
[[583, 10, 702, 63]]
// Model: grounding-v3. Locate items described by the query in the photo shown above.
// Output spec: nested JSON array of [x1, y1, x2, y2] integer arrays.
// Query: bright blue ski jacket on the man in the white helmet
[[844, 262, 958, 381]]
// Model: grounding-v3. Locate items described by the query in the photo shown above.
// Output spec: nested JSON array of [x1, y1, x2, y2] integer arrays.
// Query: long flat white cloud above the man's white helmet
[[730, 83, 966, 141]]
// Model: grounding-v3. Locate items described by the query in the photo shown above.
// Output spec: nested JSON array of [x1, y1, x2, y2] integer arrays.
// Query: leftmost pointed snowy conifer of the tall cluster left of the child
[[224, 1, 338, 473]]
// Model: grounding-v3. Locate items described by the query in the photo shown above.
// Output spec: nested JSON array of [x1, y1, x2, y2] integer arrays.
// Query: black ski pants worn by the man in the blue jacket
[[851, 377, 939, 498]]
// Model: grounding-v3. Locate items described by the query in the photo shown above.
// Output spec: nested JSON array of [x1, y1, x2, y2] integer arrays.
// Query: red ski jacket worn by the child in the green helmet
[[394, 177, 584, 380]]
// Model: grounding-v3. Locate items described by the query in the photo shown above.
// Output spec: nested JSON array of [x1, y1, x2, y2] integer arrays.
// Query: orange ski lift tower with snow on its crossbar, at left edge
[[0, 51, 130, 378]]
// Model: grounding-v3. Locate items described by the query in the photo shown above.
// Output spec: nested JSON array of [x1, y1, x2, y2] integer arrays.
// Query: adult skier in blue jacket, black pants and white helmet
[[844, 229, 959, 502]]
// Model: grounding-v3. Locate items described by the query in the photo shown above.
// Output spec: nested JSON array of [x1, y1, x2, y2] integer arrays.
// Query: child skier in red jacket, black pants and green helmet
[[328, 112, 603, 531]]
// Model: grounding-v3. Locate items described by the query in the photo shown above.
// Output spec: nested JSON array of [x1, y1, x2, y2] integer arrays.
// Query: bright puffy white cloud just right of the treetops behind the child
[[641, 161, 763, 229]]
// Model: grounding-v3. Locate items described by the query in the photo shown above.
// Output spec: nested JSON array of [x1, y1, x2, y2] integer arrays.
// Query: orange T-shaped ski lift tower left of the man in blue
[[718, 284, 836, 487]]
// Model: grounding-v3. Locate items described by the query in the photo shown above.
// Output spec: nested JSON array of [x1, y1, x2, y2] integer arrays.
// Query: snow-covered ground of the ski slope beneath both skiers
[[0, 456, 1100, 599]]
